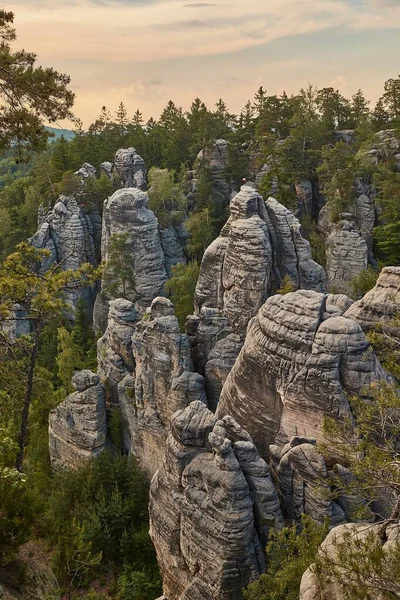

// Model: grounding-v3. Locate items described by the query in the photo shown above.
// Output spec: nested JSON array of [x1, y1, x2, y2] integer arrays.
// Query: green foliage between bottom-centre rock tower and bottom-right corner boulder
[[243, 515, 328, 600]]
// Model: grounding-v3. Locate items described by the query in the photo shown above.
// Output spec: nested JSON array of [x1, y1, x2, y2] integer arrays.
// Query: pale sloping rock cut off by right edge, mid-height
[[345, 267, 400, 337]]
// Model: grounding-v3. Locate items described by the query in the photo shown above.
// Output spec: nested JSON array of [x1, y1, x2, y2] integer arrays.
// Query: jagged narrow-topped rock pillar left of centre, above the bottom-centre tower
[[118, 298, 206, 477]]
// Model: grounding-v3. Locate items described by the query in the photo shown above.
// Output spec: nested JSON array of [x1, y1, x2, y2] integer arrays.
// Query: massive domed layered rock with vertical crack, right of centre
[[216, 290, 390, 458]]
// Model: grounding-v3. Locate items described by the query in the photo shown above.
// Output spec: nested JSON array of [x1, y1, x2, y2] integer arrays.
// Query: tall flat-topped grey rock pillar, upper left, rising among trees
[[94, 188, 167, 331]]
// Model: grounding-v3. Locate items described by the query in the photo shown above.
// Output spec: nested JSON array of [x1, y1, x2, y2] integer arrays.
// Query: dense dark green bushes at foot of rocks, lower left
[[42, 452, 157, 583]]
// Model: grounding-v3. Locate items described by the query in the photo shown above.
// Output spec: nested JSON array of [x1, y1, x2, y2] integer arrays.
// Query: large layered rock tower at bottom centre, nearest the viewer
[[149, 402, 282, 600]]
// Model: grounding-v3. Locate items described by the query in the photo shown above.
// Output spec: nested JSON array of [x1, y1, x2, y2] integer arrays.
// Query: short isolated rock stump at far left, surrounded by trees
[[49, 371, 107, 469]]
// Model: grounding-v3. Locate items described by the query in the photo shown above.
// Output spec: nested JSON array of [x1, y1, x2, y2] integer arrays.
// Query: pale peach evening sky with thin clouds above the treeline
[[5, 0, 400, 126]]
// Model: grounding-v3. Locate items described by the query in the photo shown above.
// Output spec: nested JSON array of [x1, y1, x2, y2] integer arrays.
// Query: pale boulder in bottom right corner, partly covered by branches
[[300, 523, 400, 600]]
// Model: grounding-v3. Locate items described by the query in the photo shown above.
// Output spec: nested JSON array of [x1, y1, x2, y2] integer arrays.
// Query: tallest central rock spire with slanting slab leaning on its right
[[189, 186, 325, 405]]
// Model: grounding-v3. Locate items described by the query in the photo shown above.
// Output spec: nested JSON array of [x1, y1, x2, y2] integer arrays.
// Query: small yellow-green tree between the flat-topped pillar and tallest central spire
[[165, 261, 200, 331]]
